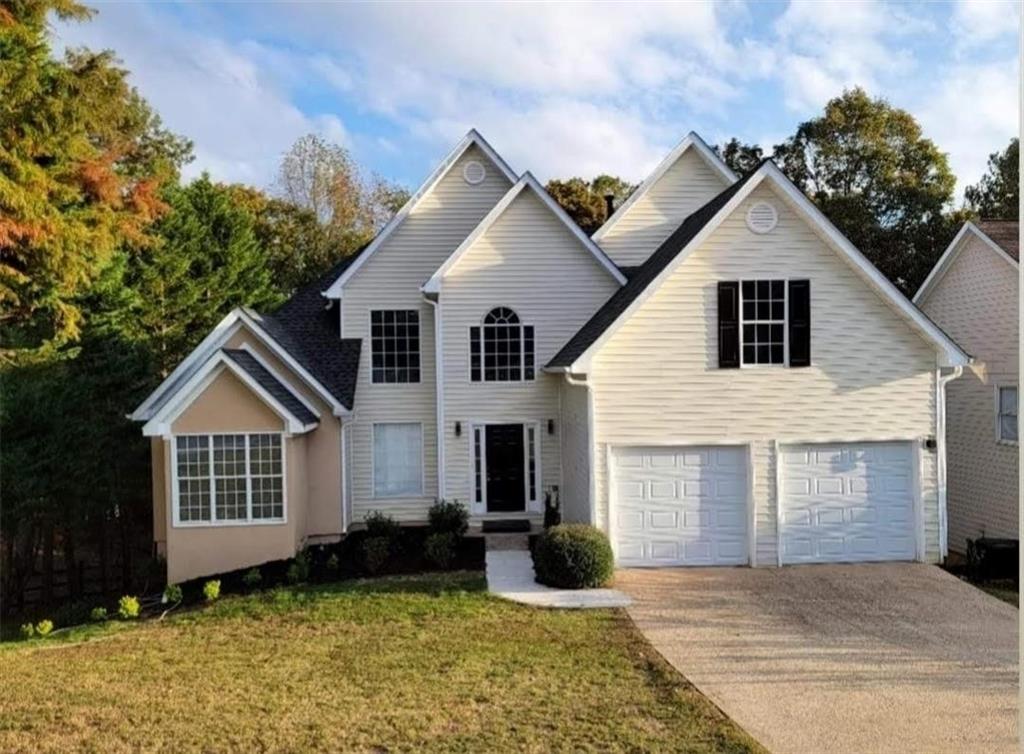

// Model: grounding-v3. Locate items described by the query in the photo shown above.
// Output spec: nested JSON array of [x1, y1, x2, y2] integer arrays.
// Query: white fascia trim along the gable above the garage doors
[[569, 162, 971, 374]]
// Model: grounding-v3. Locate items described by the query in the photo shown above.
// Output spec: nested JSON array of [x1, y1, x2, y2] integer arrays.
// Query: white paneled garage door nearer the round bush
[[611, 447, 748, 567]]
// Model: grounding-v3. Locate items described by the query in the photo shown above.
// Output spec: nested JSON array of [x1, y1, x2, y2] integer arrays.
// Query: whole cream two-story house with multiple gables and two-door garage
[[133, 131, 969, 582]]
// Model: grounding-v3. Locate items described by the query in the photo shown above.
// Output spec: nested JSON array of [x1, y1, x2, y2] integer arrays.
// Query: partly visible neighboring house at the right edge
[[913, 220, 1020, 553]]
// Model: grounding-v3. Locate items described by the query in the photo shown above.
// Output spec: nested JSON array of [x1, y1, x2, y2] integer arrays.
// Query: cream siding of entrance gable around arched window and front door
[[440, 190, 618, 512]]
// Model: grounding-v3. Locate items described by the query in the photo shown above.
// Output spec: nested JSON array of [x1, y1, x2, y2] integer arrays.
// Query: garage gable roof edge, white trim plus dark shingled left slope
[[547, 161, 970, 373]]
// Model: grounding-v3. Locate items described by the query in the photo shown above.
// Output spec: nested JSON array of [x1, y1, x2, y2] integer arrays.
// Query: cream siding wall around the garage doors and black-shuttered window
[[591, 181, 938, 564]]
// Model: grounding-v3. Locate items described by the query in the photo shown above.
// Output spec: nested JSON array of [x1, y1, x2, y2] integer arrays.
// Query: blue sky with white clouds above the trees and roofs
[[53, 0, 1020, 200]]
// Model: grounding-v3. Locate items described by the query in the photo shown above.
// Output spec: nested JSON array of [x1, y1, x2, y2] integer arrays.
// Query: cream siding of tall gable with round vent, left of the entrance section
[[342, 146, 511, 521]]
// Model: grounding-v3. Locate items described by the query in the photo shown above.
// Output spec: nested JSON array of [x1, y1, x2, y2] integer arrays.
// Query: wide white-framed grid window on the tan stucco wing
[[175, 433, 285, 523]]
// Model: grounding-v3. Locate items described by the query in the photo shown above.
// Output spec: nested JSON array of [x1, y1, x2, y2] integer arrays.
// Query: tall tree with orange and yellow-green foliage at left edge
[[0, 0, 190, 361]]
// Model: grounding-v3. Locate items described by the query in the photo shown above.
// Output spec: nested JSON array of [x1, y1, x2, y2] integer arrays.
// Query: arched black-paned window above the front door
[[469, 306, 534, 382]]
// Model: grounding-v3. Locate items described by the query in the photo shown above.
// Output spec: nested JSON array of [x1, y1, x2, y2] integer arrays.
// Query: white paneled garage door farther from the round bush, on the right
[[781, 443, 915, 562]]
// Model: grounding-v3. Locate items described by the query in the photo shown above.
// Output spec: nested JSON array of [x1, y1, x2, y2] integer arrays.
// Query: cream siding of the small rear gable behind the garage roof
[[601, 149, 728, 266]]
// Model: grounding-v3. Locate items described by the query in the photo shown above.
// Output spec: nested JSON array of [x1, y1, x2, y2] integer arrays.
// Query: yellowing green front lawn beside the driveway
[[0, 574, 762, 752]]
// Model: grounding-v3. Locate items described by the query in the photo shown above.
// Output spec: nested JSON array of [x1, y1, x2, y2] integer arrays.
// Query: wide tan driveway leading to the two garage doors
[[615, 563, 1018, 754]]
